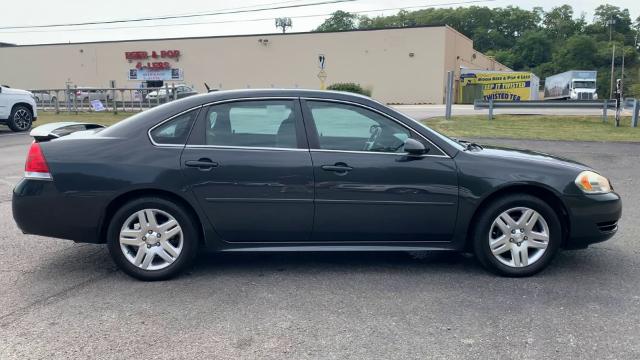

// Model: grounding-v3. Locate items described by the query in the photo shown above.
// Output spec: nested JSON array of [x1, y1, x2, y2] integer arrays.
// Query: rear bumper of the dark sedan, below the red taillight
[[12, 179, 102, 243]]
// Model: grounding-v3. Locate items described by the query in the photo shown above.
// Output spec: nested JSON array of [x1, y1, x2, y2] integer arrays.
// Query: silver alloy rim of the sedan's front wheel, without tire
[[489, 207, 550, 268]]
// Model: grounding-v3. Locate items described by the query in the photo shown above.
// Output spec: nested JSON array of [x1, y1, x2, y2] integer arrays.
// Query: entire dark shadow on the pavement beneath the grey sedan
[[22, 244, 629, 281]]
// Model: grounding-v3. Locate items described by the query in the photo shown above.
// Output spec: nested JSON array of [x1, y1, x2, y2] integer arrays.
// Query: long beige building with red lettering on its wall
[[0, 26, 509, 104]]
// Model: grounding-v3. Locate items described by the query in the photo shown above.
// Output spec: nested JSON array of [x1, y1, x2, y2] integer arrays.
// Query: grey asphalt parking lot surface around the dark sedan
[[0, 127, 640, 359]]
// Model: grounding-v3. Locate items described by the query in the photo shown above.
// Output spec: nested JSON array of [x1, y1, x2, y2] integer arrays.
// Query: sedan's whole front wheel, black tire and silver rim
[[473, 194, 562, 277]]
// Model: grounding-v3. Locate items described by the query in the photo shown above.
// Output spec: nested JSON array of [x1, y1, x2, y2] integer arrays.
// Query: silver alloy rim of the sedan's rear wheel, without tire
[[120, 209, 184, 271]]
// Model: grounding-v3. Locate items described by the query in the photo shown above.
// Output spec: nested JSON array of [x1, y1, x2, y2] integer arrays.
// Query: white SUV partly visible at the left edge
[[0, 86, 38, 131]]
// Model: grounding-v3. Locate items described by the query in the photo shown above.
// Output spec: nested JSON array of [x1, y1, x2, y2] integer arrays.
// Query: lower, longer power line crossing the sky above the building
[[0, 0, 497, 34]]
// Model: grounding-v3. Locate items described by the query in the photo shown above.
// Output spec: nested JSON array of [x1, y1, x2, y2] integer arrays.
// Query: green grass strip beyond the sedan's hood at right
[[422, 115, 640, 142]]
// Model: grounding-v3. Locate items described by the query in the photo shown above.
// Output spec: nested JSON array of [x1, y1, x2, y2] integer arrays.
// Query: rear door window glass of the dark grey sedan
[[205, 100, 298, 148]]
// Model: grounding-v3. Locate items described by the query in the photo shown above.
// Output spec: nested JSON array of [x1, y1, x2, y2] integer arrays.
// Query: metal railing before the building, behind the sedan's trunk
[[30, 85, 185, 114]]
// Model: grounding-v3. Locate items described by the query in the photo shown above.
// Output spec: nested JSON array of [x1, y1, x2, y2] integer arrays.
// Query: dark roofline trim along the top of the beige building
[[3, 25, 450, 48]]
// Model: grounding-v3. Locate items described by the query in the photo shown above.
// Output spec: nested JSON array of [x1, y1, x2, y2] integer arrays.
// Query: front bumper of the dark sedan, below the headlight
[[564, 192, 622, 249]]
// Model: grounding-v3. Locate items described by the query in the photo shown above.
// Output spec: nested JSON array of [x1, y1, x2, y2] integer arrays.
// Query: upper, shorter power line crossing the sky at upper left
[[0, 0, 356, 30]]
